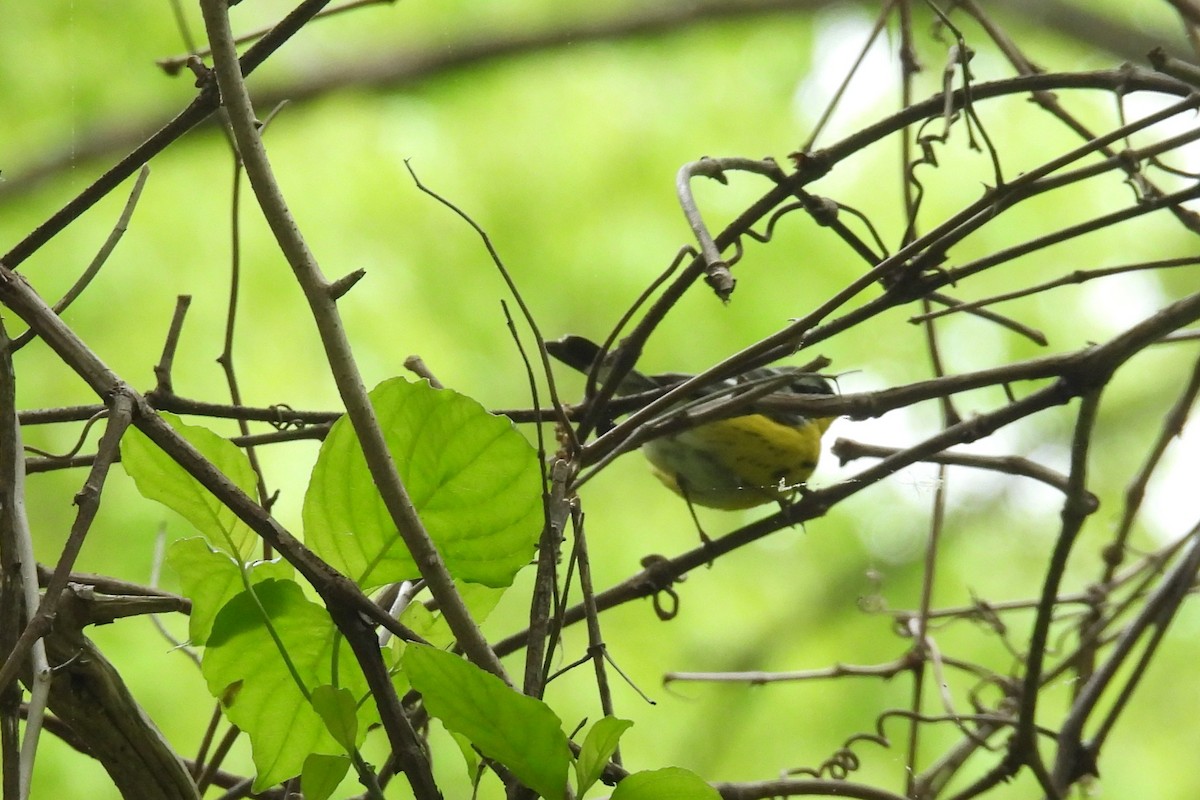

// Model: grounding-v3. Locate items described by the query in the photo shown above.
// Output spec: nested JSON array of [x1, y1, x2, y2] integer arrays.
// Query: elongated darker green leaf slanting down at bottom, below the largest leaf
[[404, 644, 571, 800]]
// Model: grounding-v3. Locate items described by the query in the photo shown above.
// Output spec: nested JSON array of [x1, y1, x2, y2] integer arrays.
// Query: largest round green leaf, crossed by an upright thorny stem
[[304, 378, 541, 588]]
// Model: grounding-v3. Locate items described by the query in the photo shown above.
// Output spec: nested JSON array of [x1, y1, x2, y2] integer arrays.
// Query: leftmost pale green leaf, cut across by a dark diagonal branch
[[121, 411, 258, 561]]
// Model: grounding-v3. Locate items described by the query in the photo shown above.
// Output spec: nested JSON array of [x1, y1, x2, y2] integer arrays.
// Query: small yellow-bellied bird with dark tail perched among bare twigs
[[546, 336, 833, 510]]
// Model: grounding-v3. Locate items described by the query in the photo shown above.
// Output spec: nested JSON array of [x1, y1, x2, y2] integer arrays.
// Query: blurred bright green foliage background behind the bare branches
[[7, 0, 1200, 800]]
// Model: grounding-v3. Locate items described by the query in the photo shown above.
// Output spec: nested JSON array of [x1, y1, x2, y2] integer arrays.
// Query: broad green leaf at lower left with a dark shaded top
[[200, 581, 378, 792]]
